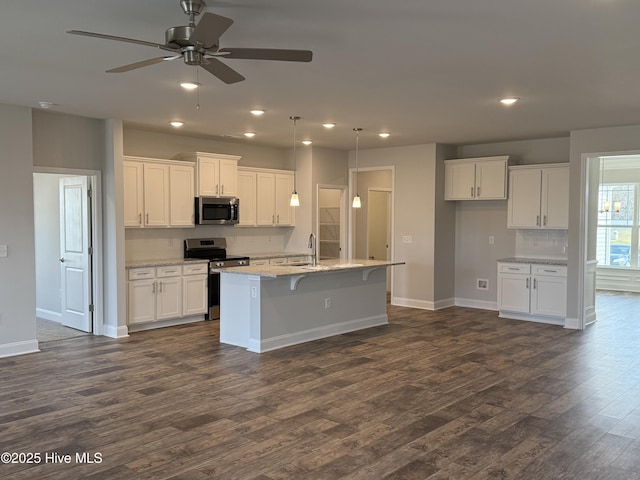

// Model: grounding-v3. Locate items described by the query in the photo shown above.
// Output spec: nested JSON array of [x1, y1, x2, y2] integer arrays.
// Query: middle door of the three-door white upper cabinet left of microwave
[[143, 163, 169, 227]]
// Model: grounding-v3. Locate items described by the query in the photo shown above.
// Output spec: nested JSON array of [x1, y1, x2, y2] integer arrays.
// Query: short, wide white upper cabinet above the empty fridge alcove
[[444, 156, 509, 200]]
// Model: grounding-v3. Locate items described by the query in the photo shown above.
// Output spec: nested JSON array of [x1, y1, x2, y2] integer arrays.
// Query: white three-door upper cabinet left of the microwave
[[123, 157, 195, 228]]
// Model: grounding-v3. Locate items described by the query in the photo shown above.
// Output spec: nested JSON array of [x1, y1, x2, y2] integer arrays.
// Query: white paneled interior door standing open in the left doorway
[[60, 176, 93, 332]]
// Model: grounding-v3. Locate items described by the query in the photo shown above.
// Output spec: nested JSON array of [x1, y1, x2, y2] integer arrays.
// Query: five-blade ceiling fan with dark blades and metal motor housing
[[67, 0, 313, 84]]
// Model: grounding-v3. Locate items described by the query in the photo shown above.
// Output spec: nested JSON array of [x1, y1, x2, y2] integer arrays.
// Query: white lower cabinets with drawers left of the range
[[127, 263, 208, 325]]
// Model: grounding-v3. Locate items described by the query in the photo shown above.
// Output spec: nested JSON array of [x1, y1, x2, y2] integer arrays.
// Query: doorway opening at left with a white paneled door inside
[[33, 169, 102, 341]]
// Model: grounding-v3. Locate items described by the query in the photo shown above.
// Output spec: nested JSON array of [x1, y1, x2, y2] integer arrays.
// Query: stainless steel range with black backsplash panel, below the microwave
[[184, 238, 249, 320]]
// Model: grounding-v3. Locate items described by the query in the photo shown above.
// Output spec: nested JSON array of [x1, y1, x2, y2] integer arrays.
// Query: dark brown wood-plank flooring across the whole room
[[0, 295, 640, 480]]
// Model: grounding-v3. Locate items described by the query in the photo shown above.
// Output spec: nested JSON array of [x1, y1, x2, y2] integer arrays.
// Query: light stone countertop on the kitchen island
[[214, 259, 405, 278]]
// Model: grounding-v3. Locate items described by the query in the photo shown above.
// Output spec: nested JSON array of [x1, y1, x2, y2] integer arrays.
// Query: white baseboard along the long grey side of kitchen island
[[247, 314, 389, 353]]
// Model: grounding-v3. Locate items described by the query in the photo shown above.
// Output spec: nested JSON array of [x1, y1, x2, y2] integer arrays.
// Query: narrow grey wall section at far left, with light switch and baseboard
[[0, 104, 38, 357]]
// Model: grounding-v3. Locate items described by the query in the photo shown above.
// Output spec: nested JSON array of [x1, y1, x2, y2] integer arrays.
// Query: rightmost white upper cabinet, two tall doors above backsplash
[[507, 163, 569, 229]]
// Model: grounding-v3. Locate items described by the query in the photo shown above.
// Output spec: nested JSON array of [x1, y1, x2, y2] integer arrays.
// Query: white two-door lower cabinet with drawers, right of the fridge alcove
[[498, 262, 567, 325]]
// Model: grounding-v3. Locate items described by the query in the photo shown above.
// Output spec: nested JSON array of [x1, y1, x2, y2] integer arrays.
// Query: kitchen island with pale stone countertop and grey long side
[[219, 259, 404, 353]]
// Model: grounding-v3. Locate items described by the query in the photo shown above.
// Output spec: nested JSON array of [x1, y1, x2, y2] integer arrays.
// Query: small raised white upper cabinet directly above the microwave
[[180, 152, 240, 197]]
